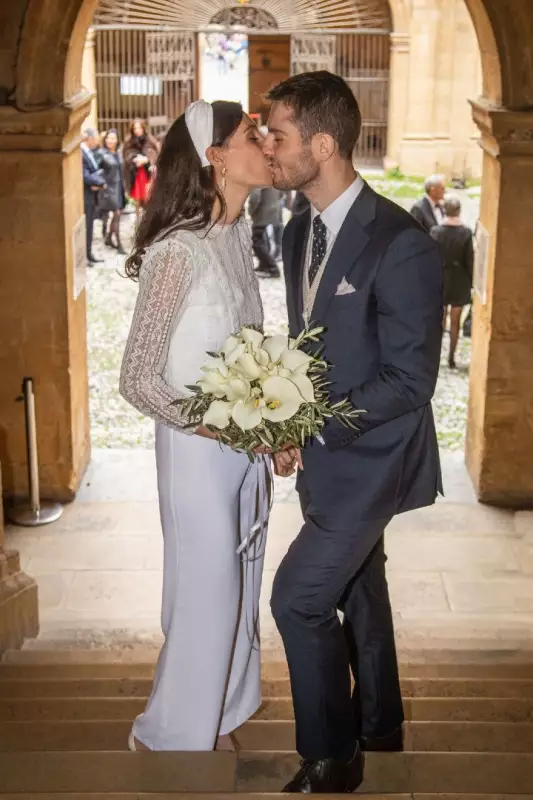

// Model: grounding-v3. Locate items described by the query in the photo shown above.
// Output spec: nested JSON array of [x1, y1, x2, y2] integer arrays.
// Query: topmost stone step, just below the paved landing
[[4, 645, 533, 680]]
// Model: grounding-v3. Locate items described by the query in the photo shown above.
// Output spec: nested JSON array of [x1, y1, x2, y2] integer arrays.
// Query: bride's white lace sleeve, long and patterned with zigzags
[[119, 240, 194, 433]]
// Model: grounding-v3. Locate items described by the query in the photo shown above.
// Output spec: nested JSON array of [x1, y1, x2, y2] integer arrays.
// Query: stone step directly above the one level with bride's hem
[[0, 697, 533, 723]]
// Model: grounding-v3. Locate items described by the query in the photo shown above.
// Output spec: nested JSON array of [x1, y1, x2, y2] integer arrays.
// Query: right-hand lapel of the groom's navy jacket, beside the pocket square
[[311, 184, 376, 322]]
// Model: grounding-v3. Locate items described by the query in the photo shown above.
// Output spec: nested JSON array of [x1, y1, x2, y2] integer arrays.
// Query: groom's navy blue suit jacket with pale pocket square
[[283, 184, 443, 529]]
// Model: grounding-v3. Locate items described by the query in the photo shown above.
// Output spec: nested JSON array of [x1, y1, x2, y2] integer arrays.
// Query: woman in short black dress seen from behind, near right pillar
[[431, 195, 474, 369]]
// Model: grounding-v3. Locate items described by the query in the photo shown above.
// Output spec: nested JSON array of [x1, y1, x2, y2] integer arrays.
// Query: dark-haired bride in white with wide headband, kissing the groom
[[120, 100, 272, 750]]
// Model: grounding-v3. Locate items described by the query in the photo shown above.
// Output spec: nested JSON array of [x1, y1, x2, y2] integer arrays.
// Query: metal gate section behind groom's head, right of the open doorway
[[291, 29, 390, 167]]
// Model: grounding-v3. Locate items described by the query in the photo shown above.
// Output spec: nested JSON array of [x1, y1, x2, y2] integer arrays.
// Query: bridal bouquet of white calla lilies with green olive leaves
[[176, 327, 362, 458]]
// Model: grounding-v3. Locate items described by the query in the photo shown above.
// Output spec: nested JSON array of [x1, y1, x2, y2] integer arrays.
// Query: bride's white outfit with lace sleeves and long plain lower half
[[120, 220, 272, 750]]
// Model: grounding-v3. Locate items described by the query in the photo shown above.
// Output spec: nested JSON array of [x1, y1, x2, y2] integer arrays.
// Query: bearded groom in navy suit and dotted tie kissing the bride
[[265, 72, 442, 793]]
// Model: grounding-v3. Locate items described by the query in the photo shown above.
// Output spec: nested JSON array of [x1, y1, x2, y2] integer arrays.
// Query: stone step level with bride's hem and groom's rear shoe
[[0, 720, 533, 753]]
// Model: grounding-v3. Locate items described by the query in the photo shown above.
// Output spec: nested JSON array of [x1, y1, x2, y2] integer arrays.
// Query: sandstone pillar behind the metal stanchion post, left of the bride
[[0, 94, 91, 501]]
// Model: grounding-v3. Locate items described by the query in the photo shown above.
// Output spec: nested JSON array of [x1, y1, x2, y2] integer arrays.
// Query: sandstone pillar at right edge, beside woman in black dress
[[466, 101, 533, 508]]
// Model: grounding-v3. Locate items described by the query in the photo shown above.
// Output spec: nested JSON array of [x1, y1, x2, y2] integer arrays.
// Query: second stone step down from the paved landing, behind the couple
[[0, 674, 533, 699]]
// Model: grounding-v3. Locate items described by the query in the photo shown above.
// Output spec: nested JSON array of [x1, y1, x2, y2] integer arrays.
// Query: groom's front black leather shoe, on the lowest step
[[283, 745, 364, 794]]
